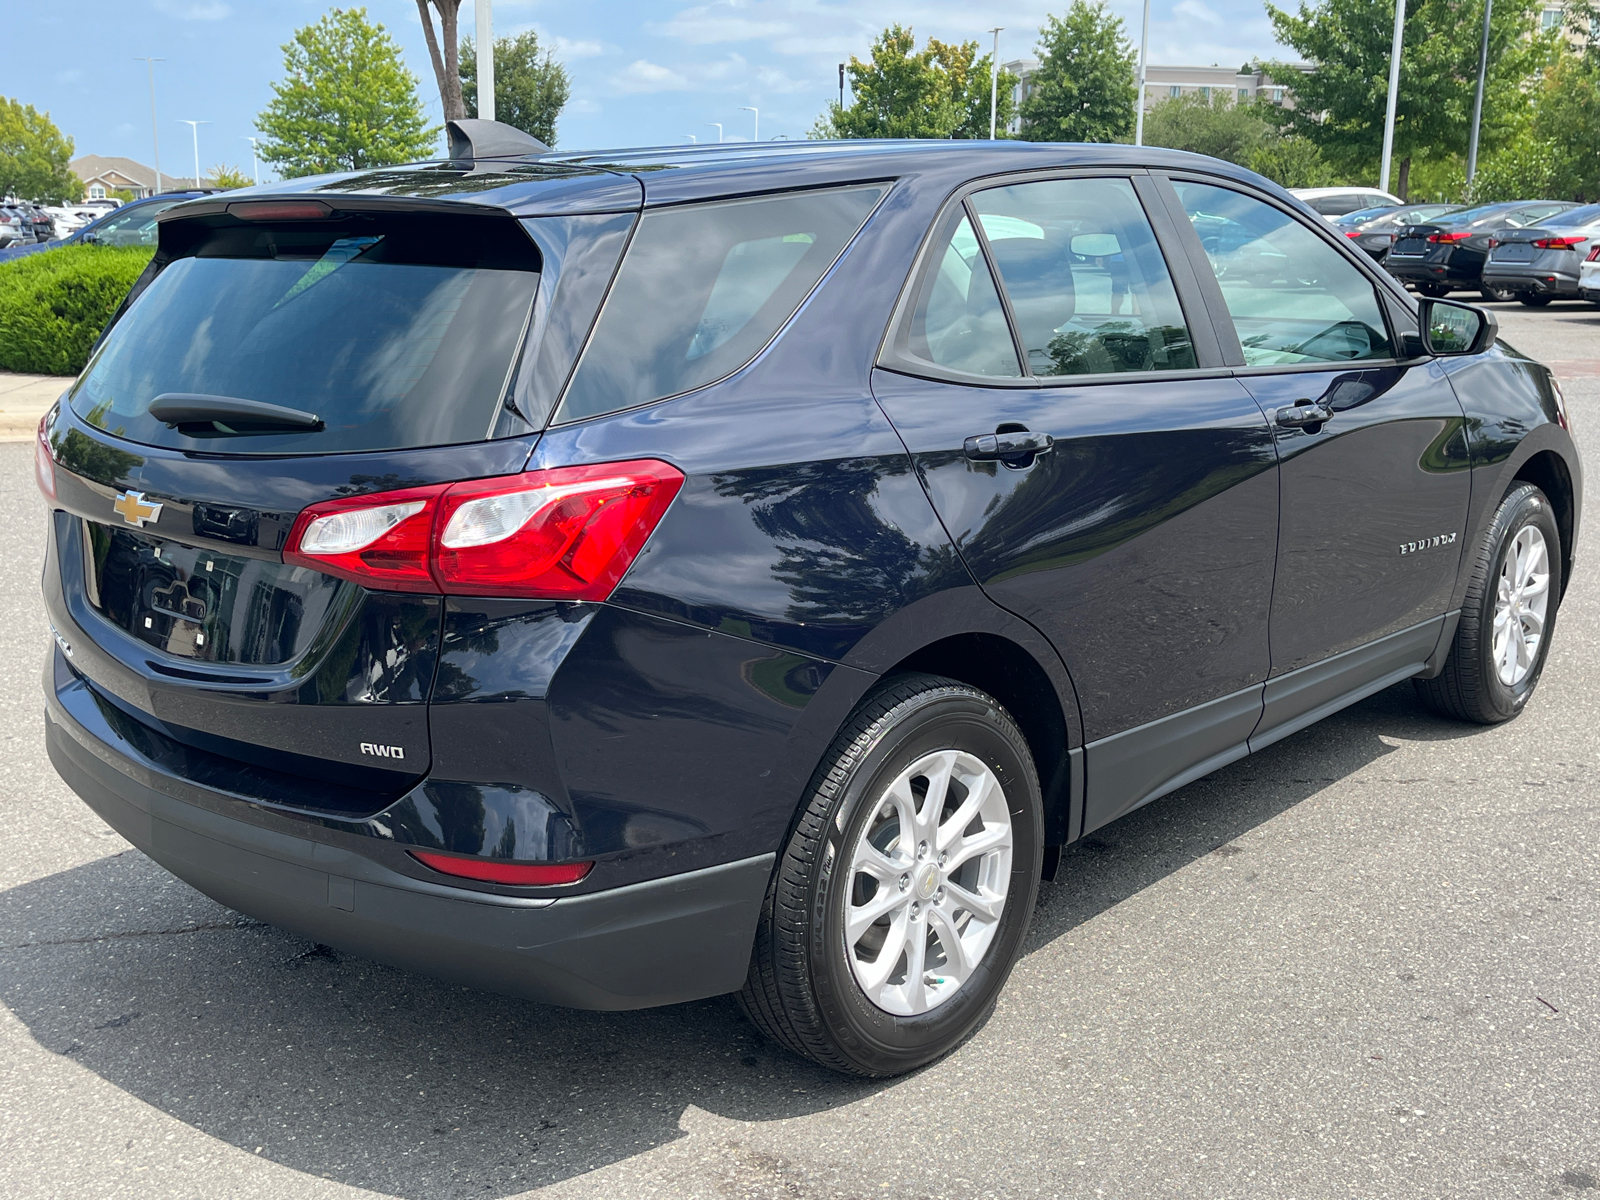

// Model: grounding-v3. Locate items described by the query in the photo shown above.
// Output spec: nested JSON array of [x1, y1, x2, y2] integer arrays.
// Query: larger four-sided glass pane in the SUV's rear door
[[970, 179, 1195, 376]]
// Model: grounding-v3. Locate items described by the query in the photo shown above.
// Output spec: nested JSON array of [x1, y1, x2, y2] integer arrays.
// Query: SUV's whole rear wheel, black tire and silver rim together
[[739, 674, 1043, 1077]]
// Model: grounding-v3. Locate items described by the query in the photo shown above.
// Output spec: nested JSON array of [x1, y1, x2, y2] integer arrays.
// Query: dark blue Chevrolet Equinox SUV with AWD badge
[[38, 123, 1581, 1075]]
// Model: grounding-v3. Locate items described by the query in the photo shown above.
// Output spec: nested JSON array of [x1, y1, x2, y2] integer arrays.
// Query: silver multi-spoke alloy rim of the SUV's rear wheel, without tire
[[845, 750, 1013, 1016]]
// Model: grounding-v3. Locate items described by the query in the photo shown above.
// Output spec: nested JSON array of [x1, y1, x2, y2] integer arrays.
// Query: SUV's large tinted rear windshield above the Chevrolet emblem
[[72, 214, 539, 454]]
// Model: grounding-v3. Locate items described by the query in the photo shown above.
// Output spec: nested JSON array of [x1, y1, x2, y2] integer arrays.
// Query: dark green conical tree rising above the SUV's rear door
[[1022, 0, 1139, 142]]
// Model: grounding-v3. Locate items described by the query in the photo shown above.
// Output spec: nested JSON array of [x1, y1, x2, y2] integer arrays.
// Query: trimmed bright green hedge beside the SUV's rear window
[[0, 246, 155, 374]]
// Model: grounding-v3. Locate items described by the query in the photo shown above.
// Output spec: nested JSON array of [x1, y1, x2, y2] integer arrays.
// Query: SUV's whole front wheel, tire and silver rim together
[[1416, 483, 1562, 725]]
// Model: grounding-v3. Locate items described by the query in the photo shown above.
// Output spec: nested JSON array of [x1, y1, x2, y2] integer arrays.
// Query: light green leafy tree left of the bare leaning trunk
[[256, 8, 438, 178]]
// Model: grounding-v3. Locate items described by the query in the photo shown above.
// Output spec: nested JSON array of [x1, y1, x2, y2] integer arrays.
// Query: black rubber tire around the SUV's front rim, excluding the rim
[[1414, 483, 1562, 725]]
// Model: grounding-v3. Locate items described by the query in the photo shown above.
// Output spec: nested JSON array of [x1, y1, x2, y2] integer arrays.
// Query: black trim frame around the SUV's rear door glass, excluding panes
[[874, 165, 1232, 389]]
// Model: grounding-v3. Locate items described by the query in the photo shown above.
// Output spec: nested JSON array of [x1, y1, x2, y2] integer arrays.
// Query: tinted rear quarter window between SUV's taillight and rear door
[[555, 184, 885, 421]]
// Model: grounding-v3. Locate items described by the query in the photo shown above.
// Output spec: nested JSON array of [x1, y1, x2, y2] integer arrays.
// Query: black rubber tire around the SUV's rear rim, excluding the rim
[[739, 674, 1043, 1077]]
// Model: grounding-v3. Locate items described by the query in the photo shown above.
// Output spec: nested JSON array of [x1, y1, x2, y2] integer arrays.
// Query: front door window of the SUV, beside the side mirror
[[1173, 181, 1394, 366]]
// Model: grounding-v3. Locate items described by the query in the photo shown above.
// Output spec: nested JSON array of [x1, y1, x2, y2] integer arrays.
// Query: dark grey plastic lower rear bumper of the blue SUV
[[45, 685, 773, 1010]]
